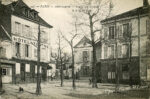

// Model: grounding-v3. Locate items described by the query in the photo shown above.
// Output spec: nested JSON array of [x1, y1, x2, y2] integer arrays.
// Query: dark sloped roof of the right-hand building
[[101, 6, 150, 23]]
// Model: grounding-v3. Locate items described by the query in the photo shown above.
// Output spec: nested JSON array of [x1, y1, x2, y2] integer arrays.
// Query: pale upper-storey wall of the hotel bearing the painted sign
[[11, 15, 50, 62]]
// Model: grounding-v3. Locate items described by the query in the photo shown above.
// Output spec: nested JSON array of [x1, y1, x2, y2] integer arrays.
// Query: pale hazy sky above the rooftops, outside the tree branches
[[2, 0, 150, 52]]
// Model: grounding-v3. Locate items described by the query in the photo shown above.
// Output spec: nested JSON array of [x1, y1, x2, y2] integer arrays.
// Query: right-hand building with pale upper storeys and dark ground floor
[[97, 0, 150, 84]]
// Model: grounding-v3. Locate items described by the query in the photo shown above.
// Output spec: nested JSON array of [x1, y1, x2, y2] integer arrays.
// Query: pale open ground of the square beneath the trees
[[0, 80, 148, 99]]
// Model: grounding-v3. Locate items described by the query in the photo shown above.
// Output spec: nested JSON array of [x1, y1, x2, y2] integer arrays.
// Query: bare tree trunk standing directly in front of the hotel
[[36, 23, 42, 95]]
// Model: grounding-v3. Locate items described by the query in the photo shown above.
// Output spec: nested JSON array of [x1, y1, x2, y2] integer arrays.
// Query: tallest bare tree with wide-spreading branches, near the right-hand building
[[71, 0, 113, 88]]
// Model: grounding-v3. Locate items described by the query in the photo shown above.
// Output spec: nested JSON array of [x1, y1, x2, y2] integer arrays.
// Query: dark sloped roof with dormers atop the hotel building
[[6, 0, 53, 28]]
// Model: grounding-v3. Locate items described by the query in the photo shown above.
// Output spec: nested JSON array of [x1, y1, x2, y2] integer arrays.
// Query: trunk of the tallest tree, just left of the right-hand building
[[89, 16, 97, 88]]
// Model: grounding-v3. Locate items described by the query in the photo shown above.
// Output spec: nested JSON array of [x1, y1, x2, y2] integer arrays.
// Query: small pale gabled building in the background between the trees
[[74, 36, 92, 77]]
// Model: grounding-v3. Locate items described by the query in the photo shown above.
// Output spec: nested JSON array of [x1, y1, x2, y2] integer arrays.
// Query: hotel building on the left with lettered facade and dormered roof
[[0, 0, 52, 83]]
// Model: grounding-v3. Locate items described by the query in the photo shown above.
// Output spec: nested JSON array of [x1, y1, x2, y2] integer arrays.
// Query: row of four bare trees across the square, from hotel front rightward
[[0, 0, 113, 95]]
